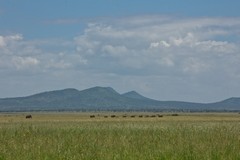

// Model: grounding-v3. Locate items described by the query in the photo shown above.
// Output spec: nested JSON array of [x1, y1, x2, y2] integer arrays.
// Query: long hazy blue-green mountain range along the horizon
[[0, 87, 240, 112]]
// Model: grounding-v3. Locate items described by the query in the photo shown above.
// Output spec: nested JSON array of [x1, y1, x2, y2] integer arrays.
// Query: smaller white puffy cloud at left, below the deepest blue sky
[[0, 34, 91, 73]]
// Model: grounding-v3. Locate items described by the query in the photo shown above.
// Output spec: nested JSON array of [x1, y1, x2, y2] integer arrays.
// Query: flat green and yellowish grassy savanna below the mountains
[[0, 112, 240, 160]]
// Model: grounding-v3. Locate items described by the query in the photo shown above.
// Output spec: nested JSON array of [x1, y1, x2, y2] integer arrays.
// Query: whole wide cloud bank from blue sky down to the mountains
[[0, 15, 240, 101]]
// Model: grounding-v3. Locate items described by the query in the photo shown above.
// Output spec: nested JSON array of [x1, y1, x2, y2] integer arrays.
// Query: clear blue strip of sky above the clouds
[[0, 0, 240, 38]]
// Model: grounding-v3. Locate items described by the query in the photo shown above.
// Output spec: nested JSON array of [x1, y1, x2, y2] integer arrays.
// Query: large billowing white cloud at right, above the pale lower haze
[[75, 16, 240, 74]]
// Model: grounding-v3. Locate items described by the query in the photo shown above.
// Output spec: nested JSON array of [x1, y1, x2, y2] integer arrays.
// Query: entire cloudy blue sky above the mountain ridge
[[0, 0, 240, 103]]
